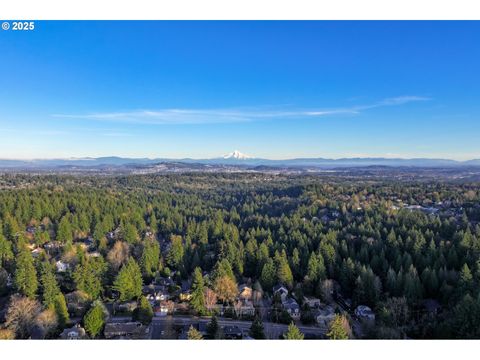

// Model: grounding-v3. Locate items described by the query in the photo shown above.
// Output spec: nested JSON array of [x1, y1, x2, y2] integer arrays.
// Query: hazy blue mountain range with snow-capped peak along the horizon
[[0, 150, 480, 169]]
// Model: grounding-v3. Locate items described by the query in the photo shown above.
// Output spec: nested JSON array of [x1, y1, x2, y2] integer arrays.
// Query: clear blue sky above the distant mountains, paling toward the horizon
[[0, 21, 480, 160]]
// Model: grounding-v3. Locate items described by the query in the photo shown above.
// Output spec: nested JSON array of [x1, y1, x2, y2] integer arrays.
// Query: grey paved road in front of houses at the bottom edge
[[150, 316, 327, 339]]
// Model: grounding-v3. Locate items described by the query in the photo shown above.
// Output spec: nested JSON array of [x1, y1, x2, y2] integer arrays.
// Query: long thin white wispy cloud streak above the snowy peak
[[52, 96, 430, 125]]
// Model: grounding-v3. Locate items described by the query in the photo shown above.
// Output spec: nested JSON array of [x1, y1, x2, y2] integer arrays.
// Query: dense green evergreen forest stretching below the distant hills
[[0, 173, 480, 338]]
